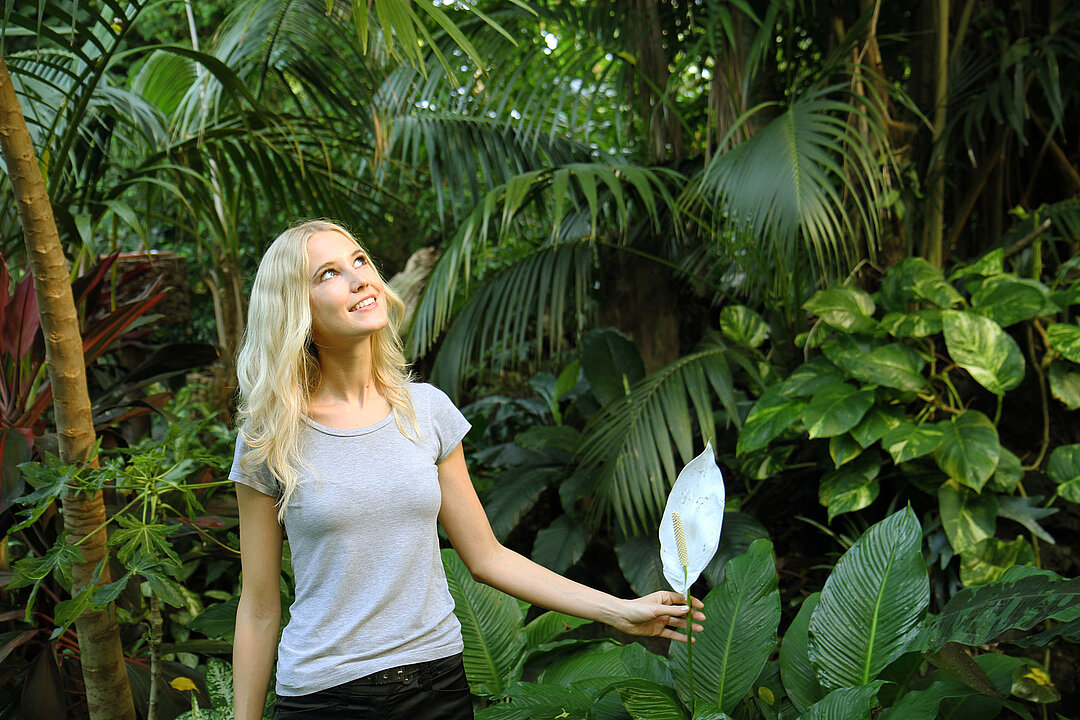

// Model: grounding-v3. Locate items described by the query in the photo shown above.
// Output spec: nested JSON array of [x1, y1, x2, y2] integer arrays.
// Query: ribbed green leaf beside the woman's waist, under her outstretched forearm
[[443, 549, 525, 695]]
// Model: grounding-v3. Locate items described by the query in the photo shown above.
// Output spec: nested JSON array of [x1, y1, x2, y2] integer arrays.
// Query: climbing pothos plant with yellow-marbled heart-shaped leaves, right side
[[734, 203, 1080, 584]]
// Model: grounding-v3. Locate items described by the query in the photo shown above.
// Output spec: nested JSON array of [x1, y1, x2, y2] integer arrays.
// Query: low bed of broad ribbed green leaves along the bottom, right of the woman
[[444, 508, 1080, 720]]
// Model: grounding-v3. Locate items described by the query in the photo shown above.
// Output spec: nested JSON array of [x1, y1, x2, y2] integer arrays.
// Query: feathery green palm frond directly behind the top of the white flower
[[576, 335, 757, 534]]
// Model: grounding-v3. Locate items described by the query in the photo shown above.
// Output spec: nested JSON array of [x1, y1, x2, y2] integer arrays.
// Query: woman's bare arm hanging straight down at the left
[[232, 483, 282, 720]]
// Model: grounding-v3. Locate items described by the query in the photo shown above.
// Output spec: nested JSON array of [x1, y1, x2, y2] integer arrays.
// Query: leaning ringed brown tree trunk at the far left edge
[[0, 55, 135, 720]]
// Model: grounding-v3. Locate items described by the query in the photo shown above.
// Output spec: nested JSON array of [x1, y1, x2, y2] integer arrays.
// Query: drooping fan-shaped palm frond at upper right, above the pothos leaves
[[683, 85, 888, 270]]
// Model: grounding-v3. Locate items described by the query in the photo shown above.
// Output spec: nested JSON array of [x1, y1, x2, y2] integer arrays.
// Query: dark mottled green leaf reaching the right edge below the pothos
[[918, 567, 1080, 652]]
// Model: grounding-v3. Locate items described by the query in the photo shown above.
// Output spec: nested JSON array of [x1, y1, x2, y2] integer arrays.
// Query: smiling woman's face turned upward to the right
[[308, 230, 387, 348]]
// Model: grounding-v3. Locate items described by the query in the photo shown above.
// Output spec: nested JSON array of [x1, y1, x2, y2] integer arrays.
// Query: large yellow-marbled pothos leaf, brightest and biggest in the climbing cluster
[[943, 310, 1024, 395]]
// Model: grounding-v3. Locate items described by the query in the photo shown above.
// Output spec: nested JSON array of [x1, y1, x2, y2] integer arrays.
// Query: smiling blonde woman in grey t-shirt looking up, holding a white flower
[[230, 221, 704, 720]]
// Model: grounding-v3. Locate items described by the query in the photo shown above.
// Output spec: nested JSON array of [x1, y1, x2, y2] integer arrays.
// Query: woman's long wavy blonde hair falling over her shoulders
[[237, 220, 419, 521]]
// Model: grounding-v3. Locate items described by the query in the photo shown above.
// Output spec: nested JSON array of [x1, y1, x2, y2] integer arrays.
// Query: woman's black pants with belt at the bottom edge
[[274, 654, 473, 720]]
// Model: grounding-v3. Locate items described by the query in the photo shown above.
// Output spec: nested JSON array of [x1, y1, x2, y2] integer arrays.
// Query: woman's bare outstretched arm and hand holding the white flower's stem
[[438, 444, 705, 641]]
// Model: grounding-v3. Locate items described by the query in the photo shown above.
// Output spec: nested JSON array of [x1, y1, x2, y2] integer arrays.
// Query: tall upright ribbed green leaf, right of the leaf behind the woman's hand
[[810, 507, 930, 690]]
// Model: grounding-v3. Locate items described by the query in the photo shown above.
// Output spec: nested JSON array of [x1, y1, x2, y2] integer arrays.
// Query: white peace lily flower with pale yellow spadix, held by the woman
[[660, 443, 724, 597]]
